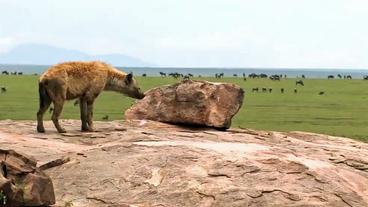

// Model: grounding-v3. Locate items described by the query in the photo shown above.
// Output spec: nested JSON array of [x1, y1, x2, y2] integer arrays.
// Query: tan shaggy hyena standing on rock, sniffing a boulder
[[37, 61, 144, 133]]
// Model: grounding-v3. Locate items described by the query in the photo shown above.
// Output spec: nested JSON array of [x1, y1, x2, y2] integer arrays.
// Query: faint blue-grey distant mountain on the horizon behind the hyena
[[0, 44, 153, 67]]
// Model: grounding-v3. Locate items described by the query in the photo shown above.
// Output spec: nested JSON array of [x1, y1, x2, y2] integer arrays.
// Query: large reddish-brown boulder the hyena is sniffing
[[125, 80, 244, 129]]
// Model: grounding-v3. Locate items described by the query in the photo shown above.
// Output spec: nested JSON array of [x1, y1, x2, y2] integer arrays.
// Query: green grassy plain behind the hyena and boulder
[[0, 76, 368, 141]]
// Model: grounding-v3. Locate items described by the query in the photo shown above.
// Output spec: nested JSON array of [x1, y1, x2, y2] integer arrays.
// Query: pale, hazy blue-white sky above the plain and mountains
[[0, 0, 368, 69]]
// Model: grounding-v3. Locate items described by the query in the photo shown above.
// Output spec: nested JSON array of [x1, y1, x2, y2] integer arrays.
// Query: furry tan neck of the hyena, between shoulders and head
[[104, 68, 126, 93]]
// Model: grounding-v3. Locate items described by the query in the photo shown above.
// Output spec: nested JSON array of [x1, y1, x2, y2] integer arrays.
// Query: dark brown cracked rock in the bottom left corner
[[0, 149, 55, 207]]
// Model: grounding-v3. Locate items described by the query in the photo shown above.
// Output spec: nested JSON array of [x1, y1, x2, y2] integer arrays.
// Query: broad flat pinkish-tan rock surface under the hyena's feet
[[0, 120, 368, 207]]
